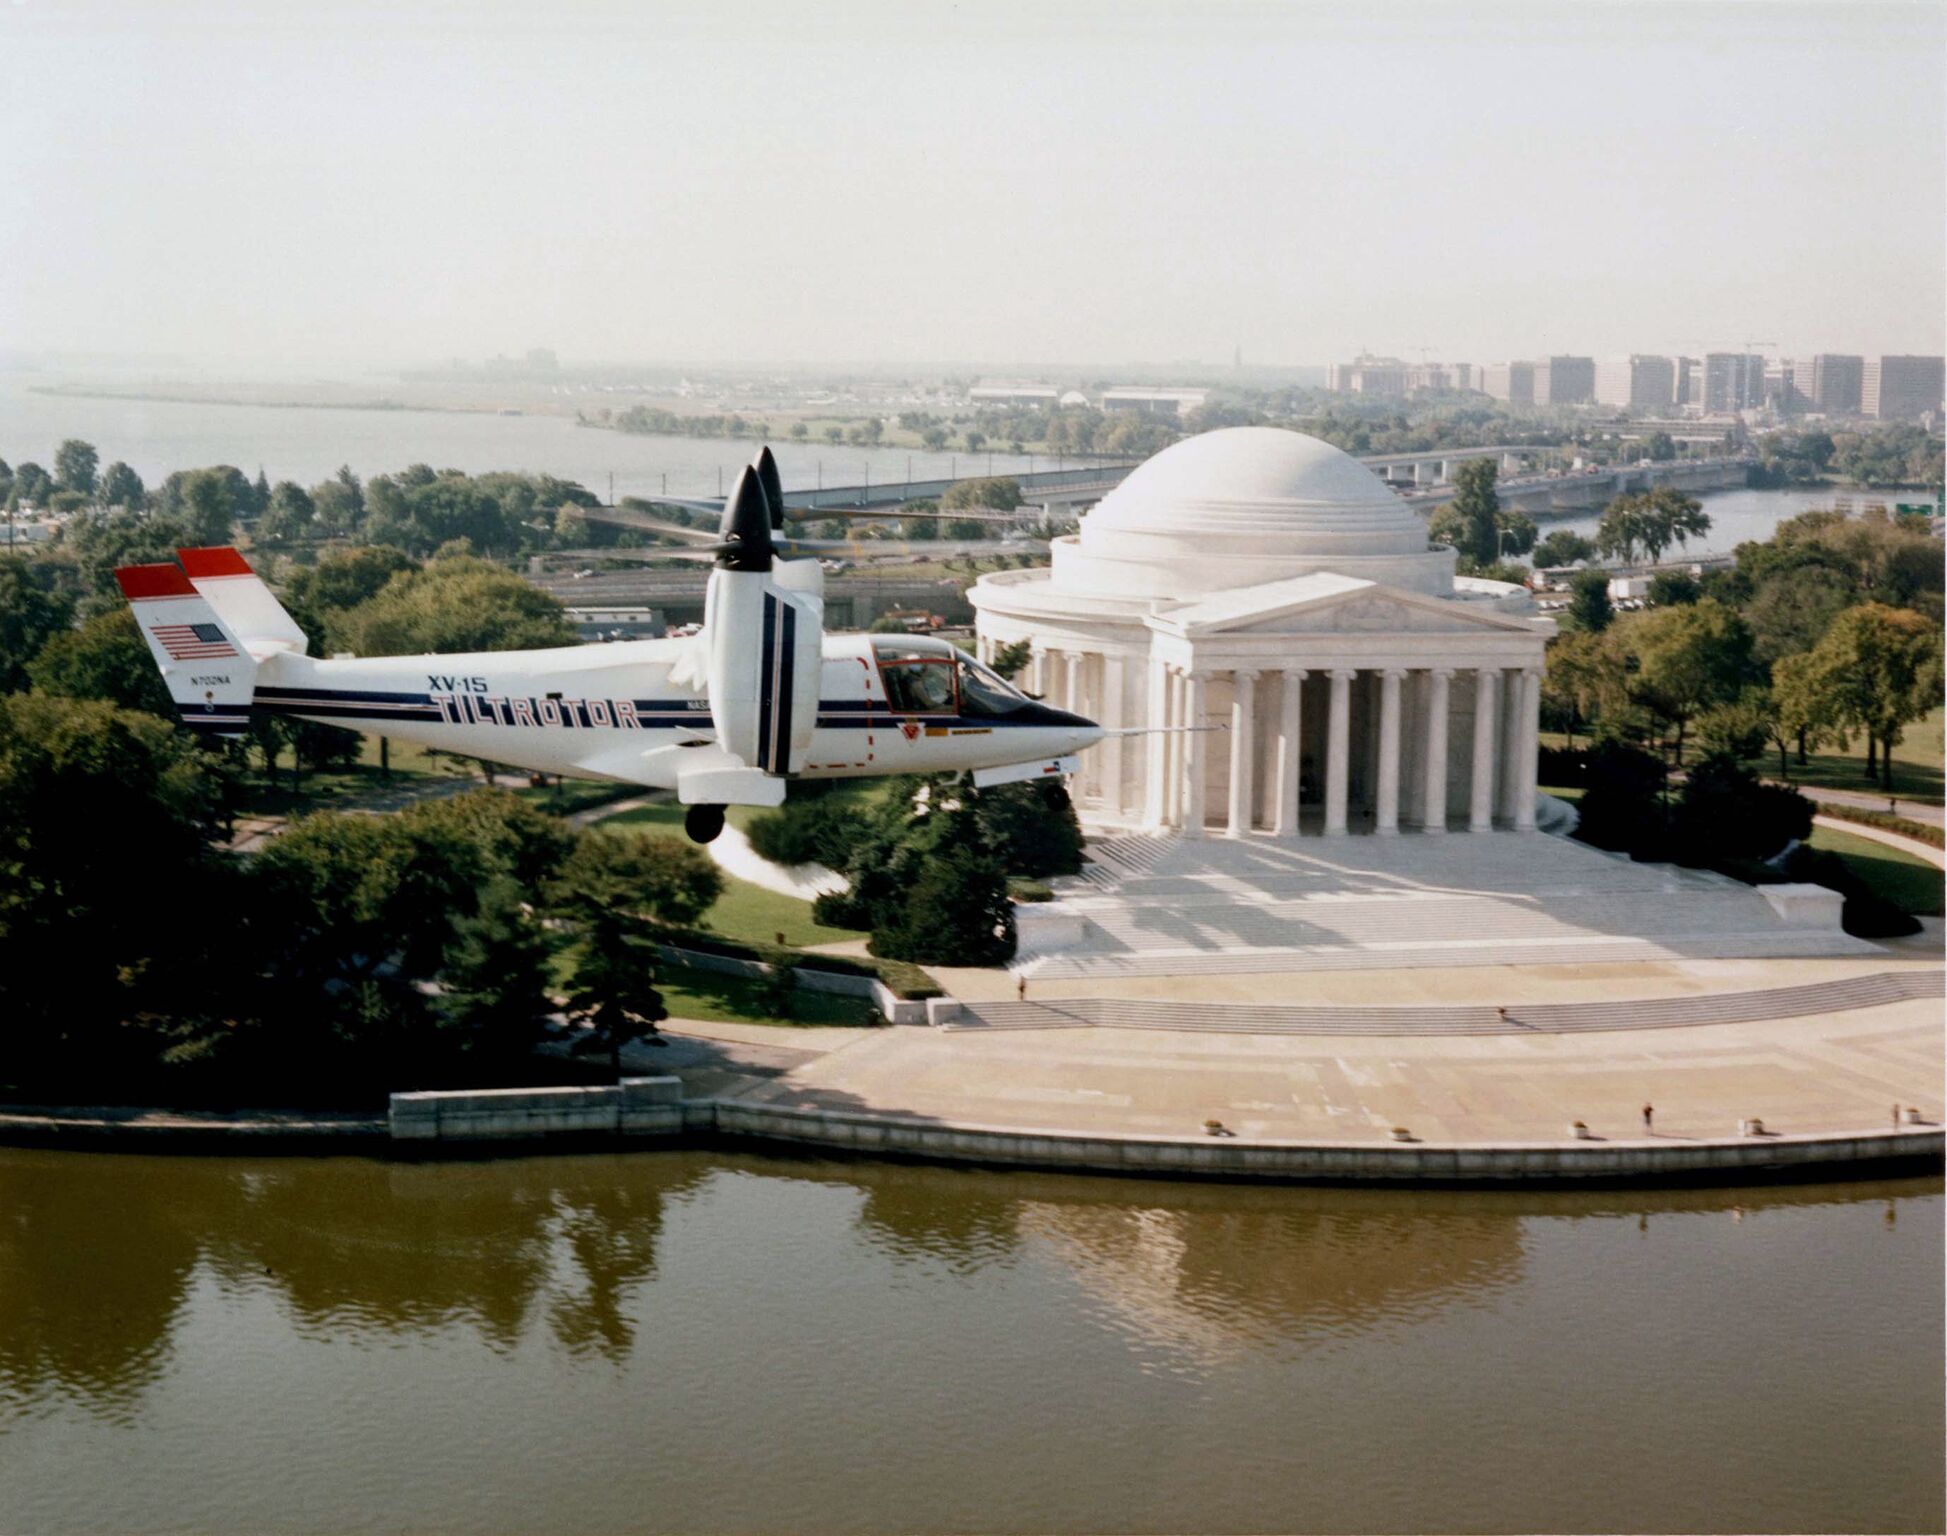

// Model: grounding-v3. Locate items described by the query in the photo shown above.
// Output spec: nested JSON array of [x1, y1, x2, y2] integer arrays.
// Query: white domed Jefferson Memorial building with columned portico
[[970, 426, 1556, 837]]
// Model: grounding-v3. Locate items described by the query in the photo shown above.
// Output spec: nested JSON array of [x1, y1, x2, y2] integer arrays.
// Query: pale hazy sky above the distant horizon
[[0, 0, 1947, 366]]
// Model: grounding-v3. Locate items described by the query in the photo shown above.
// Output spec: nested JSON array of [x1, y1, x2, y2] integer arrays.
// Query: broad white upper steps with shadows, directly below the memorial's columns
[[1014, 833, 1877, 979]]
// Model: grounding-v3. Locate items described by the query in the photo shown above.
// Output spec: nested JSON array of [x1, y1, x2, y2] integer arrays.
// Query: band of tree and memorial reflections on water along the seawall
[[0, 1152, 1939, 1423]]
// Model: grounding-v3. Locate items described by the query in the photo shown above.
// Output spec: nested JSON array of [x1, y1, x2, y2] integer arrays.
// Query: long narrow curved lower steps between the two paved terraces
[[942, 969, 1947, 1036]]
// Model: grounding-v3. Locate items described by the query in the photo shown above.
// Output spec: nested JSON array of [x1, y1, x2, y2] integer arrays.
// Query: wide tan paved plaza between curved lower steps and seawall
[[738, 999, 1943, 1147]]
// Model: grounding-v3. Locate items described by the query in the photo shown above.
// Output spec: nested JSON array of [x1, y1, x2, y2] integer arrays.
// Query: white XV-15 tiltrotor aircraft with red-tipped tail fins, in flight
[[115, 448, 1108, 843]]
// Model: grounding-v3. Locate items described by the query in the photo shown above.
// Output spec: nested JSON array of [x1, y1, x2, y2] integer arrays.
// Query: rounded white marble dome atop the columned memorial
[[1053, 426, 1454, 598]]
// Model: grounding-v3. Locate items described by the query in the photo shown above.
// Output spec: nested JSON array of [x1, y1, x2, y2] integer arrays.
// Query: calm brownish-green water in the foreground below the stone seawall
[[0, 1151, 1943, 1532]]
